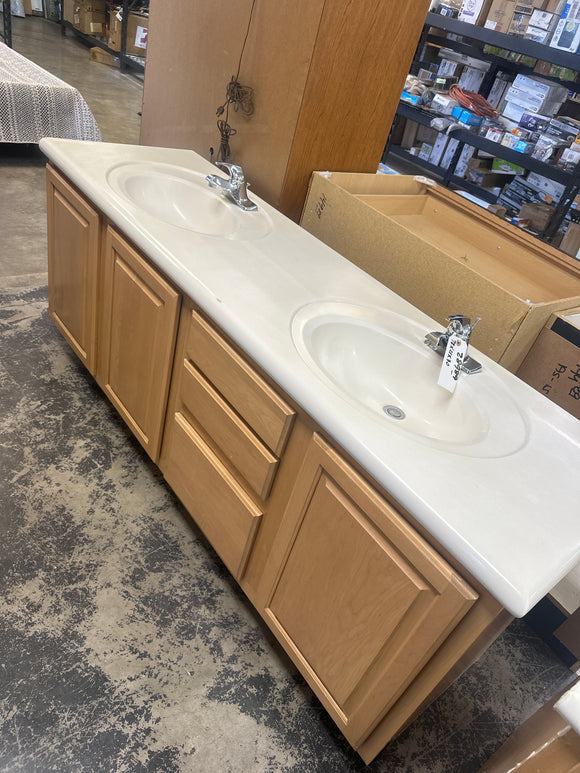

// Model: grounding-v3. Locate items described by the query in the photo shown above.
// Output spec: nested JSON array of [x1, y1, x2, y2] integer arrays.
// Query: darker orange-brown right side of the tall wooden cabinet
[[279, 0, 429, 220]]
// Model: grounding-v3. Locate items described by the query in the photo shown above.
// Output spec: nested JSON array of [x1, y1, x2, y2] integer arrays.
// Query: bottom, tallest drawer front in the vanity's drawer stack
[[165, 413, 262, 580]]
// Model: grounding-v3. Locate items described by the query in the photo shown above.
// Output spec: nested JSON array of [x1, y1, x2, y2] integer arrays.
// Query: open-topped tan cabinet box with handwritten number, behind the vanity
[[302, 172, 580, 371]]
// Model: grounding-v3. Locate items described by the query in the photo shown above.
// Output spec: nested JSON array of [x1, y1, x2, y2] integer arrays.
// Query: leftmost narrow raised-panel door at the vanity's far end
[[46, 166, 100, 375]]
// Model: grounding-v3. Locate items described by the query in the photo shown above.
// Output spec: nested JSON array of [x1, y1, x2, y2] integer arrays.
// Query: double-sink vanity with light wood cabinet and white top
[[40, 139, 580, 762]]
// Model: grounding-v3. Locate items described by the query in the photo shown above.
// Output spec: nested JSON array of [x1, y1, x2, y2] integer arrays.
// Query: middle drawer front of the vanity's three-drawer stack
[[180, 360, 278, 499]]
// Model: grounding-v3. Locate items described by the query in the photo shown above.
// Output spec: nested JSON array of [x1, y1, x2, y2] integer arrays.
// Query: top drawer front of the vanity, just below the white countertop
[[186, 311, 294, 456]]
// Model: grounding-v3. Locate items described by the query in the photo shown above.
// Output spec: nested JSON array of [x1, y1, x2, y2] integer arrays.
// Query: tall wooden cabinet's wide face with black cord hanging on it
[[140, 0, 324, 206]]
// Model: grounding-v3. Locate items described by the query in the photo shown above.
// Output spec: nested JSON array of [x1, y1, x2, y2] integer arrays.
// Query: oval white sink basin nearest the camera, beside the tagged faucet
[[292, 302, 527, 457]]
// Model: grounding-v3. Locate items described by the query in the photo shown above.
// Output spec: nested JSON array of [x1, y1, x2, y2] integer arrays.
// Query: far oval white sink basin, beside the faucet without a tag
[[107, 162, 272, 239]]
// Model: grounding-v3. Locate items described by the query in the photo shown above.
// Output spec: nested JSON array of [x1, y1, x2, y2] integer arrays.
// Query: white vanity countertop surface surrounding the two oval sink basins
[[40, 139, 580, 617]]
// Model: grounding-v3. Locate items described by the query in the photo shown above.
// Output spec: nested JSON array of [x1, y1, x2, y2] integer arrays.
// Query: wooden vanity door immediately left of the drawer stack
[[97, 226, 181, 461]]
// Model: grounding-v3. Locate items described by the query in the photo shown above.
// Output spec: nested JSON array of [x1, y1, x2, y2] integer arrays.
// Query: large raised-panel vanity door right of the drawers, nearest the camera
[[259, 434, 477, 748]]
